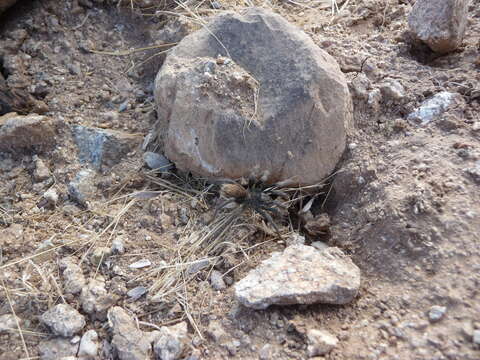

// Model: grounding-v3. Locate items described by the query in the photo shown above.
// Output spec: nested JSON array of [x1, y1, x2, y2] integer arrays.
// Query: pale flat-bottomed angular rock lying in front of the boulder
[[235, 244, 360, 309]]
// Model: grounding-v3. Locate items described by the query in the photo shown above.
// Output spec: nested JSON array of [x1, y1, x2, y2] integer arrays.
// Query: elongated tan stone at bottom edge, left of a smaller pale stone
[[108, 306, 152, 360]]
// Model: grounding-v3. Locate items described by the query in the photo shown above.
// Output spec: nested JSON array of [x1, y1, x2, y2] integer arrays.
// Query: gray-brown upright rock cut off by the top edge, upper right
[[408, 0, 470, 53]]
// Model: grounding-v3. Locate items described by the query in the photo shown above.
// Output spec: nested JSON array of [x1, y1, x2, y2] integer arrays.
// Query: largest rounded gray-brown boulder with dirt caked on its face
[[155, 8, 352, 184]]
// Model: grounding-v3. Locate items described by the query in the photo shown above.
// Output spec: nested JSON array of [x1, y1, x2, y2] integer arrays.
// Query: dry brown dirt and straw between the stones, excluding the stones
[[0, 0, 480, 360]]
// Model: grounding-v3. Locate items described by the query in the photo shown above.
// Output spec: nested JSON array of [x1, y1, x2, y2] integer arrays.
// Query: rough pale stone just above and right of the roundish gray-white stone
[[80, 279, 118, 320]]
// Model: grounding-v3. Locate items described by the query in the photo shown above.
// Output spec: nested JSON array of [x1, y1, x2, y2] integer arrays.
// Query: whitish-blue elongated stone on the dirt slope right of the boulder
[[407, 91, 462, 125]]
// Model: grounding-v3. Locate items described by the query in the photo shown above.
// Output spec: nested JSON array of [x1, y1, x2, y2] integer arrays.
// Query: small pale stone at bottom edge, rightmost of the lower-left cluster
[[153, 322, 187, 360]]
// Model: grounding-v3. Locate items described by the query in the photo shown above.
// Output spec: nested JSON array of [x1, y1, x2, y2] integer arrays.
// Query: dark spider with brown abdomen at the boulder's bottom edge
[[214, 181, 288, 237]]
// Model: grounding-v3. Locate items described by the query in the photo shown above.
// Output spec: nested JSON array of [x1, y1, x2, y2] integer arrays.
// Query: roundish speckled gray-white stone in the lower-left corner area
[[41, 304, 85, 337]]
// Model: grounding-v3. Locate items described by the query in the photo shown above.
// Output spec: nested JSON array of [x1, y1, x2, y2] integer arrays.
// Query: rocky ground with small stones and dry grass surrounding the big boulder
[[0, 0, 480, 360]]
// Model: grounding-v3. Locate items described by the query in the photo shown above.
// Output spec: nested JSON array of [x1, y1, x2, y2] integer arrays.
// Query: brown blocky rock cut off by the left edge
[[0, 113, 56, 152]]
